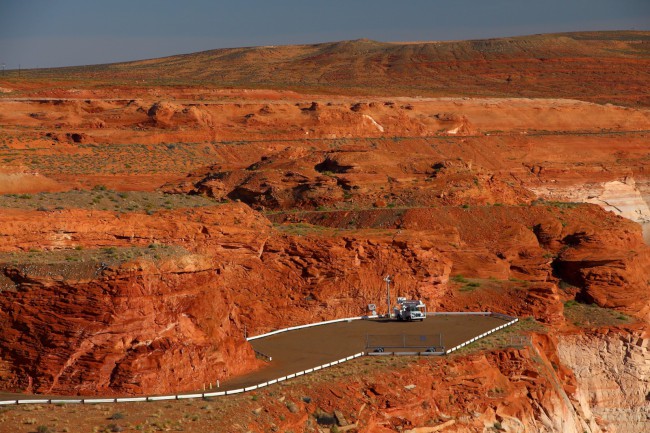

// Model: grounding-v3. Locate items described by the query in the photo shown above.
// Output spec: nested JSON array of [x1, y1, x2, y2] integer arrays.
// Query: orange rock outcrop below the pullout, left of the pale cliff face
[[250, 335, 605, 433]]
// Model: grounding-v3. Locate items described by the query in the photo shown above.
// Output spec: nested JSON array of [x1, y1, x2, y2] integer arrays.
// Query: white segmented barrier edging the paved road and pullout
[[0, 312, 518, 406]]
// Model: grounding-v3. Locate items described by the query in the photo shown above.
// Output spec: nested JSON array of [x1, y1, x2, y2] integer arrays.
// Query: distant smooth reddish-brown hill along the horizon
[[0, 31, 650, 106]]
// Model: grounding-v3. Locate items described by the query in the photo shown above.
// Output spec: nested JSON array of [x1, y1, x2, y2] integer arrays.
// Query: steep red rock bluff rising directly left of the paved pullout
[[0, 255, 258, 395]]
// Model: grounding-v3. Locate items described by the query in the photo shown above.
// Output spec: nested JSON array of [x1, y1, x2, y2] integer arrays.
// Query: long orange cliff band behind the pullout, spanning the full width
[[0, 199, 648, 394]]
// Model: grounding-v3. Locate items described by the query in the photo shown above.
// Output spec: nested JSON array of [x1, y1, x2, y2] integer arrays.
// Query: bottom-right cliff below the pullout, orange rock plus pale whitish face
[[229, 329, 648, 433]]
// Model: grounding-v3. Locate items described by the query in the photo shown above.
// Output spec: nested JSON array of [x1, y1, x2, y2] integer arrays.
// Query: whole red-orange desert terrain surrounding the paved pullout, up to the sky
[[0, 31, 650, 433]]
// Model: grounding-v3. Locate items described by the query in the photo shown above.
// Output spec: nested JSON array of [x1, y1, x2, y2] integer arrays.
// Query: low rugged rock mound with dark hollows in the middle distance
[[163, 147, 534, 210]]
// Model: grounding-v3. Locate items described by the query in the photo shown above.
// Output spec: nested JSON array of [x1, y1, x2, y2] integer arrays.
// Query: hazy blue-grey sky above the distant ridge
[[0, 0, 650, 69]]
